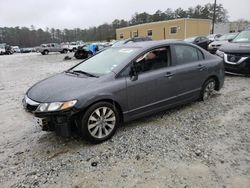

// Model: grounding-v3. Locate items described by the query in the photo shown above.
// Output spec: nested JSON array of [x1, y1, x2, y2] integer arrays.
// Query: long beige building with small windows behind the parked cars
[[116, 18, 211, 40]]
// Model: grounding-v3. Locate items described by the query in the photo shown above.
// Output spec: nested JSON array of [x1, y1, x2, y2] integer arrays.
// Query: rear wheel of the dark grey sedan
[[200, 78, 216, 101]]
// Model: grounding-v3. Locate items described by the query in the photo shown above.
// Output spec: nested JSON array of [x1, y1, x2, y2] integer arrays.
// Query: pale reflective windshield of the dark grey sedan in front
[[71, 48, 139, 75]]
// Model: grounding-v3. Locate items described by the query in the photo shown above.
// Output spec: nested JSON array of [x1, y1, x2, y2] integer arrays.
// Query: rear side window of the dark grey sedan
[[174, 45, 201, 65]]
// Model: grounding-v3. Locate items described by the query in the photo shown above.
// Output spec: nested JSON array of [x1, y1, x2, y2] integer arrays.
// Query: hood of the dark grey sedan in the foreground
[[27, 73, 102, 103]]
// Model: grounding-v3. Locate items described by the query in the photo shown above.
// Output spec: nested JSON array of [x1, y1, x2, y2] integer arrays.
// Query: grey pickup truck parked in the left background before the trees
[[38, 43, 68, 55]]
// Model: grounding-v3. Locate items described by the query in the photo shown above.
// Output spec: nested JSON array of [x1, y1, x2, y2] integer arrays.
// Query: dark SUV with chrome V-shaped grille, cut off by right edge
[[216, 30, 250, 76]]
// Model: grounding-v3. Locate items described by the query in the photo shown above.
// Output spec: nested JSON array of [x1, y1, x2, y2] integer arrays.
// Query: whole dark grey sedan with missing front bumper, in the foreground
[[23, 41, 224, 143]]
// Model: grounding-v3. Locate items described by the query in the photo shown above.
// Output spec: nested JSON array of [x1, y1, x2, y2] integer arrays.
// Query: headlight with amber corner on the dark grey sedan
[[36, 100, 77, 112]]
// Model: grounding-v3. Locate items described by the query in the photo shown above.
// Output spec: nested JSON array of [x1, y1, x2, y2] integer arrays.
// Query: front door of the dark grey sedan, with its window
[[126, 46, 178, 116]]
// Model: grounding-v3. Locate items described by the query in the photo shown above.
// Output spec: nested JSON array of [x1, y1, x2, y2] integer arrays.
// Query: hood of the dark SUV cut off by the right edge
[[220, 42, 250, 53]]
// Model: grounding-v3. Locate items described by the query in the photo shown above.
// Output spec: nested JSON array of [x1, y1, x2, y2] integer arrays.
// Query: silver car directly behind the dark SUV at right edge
[[208, 33, 238, 54]]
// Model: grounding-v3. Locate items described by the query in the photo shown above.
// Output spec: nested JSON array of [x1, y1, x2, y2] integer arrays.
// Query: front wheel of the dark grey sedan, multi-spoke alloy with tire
[[79, 102, 120, 143]]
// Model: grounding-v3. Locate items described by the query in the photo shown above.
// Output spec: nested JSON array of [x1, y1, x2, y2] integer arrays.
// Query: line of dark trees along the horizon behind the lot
[[0, 3, 228, 47]]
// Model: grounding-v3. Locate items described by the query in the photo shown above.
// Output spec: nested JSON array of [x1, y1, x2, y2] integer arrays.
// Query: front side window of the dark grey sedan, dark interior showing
[[135, 47, 170, 73]]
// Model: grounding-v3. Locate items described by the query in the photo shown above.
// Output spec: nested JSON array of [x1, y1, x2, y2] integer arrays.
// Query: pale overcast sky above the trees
[[0, 0, 250, 29]]
